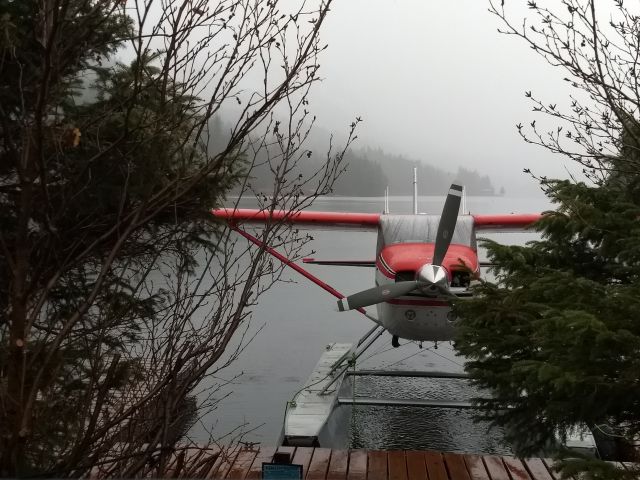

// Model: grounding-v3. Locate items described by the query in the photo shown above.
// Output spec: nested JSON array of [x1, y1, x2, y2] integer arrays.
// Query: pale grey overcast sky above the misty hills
[[302, 0, 584, 195]]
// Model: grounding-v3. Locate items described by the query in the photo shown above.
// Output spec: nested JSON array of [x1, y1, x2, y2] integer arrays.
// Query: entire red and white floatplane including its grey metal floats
[[211, 170, 596, 454]]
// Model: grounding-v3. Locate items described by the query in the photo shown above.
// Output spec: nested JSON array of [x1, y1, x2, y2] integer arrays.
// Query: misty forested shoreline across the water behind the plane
[[212, 116, 505, 197]]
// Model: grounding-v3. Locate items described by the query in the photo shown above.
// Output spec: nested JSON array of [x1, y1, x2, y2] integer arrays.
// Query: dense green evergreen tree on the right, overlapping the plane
[[456, 174, 640, 470]]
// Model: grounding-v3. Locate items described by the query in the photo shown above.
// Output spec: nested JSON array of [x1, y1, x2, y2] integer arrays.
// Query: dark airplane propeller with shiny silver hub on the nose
[[338, 184, 462, 312]]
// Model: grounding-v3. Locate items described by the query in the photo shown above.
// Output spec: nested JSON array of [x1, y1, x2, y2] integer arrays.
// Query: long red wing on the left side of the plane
[[211, 208, 381, 229]]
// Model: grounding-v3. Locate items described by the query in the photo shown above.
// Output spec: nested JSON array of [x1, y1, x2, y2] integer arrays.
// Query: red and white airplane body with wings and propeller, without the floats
[[212, 184, 541, 346]]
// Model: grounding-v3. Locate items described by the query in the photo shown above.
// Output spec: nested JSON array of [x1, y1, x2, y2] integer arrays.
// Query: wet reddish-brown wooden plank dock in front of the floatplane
[[172, 447, 560, 480]]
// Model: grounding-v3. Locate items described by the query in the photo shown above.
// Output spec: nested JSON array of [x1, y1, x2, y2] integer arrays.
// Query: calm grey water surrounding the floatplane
[[191, 195, 550, 454]]
